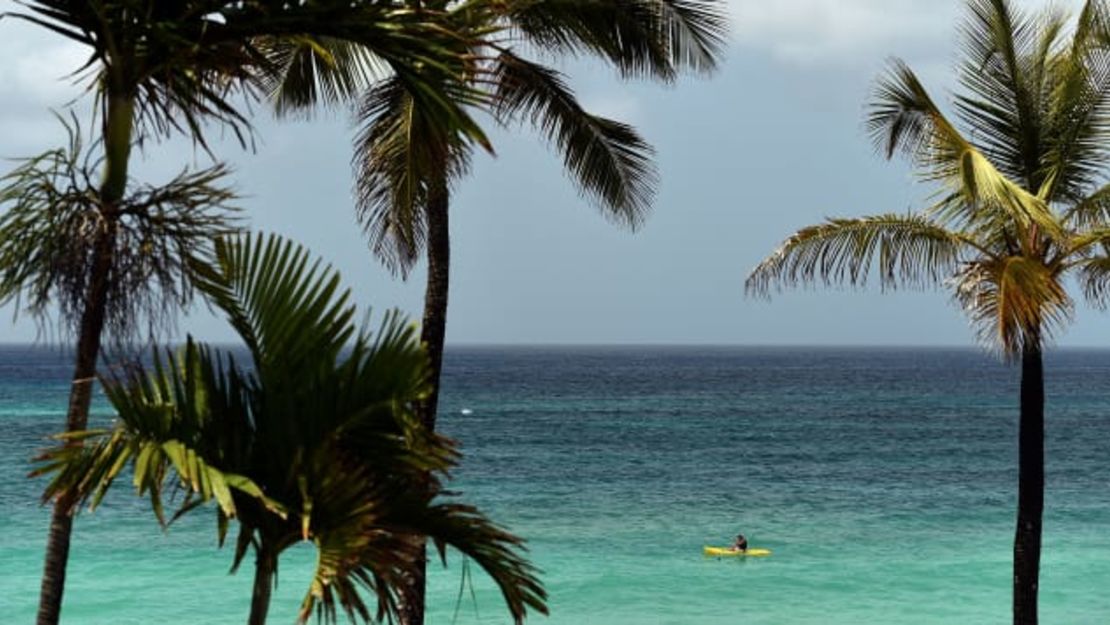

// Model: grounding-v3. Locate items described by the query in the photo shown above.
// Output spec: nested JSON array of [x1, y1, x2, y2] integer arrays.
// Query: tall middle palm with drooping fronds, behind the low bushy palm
[[271, 0, 725, 625]]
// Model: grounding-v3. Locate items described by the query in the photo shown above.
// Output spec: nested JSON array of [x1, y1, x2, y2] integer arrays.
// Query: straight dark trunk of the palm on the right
[[1013, 340, 1045, 625]]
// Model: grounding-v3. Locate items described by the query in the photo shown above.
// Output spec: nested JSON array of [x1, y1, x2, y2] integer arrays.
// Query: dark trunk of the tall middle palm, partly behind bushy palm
[[400, 178, 451, 625]]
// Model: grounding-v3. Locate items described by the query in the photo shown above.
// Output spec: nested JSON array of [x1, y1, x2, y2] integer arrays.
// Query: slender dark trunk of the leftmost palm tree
[[37, 89, 133, 625]]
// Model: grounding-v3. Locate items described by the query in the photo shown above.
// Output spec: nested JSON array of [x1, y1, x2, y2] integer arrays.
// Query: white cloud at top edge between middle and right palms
[[730, 0, 1082, 64]]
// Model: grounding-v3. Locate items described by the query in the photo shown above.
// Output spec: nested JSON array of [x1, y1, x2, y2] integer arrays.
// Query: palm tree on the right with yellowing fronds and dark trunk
[[747, 0, 1110, 625]]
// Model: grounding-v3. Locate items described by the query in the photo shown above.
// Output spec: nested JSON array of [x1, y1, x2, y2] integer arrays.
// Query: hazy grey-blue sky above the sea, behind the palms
[[0, 0, 1110, 346]]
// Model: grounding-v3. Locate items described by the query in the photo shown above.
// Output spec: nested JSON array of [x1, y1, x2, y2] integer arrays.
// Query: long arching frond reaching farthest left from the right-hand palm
[[745, 214, 977, 295]]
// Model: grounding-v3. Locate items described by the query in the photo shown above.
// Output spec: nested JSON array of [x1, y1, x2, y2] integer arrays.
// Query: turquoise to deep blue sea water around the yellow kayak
[[0, 347, 1110, 625]]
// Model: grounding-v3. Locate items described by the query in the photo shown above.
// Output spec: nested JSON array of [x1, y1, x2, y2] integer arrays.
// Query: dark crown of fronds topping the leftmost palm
[[11, 0, 482, 145]]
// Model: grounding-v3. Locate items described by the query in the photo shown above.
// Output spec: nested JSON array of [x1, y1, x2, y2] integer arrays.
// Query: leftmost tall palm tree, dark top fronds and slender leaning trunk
[[0, 0, 492, 625]]
